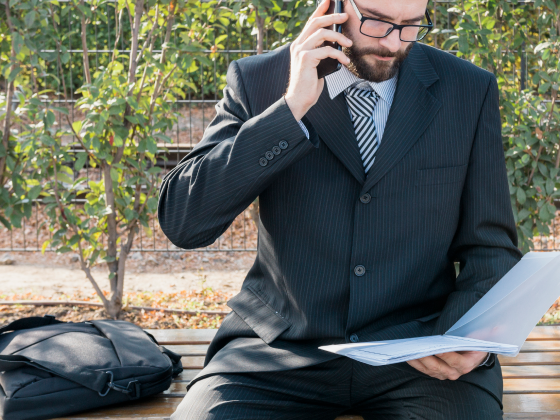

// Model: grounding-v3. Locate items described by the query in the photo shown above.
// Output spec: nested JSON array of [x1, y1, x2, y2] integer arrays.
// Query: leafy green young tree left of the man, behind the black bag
[[0, 0, 231, 317]]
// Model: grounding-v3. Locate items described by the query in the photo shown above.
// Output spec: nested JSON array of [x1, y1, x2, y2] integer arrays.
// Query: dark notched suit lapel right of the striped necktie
[[360, 43, 441, 194]]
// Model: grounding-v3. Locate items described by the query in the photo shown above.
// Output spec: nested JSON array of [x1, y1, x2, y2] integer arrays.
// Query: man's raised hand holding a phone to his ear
[[285, 0, 352, 120]]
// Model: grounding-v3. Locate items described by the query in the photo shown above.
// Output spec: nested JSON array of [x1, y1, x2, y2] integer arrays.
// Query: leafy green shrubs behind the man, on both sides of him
[[0, 0, 560, 317]]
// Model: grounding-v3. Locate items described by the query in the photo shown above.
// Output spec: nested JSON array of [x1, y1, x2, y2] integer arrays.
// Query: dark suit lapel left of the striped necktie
[[306, 82, 365, 184]]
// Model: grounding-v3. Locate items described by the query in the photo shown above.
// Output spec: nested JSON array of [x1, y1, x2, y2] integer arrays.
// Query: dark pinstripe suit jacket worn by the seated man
[[158, 43, 521, 400]]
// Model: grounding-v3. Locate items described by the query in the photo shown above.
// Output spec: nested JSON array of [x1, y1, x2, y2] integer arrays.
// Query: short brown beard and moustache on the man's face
[[342, 39, 414, 83]]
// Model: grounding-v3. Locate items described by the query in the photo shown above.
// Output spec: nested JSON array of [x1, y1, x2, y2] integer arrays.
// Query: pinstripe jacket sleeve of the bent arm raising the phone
[[158, 61, 319, 249]]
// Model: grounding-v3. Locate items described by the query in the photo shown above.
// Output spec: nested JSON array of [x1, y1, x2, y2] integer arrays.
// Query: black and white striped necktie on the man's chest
[[346, 87, 379, 174]]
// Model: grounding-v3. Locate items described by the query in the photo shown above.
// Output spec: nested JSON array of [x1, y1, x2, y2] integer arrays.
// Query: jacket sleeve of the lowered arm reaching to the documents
[[433, 75, 522, 335]]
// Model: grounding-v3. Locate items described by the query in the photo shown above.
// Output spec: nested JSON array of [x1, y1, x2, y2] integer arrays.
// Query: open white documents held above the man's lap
[[319, 252, 560, 366]]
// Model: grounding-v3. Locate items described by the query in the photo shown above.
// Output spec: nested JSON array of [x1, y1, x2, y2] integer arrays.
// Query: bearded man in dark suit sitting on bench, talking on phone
[[158, 0, 521, 420]]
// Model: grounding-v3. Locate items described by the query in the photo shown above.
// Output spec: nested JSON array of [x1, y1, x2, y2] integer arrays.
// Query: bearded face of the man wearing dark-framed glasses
[[342, 0, 427, 83]]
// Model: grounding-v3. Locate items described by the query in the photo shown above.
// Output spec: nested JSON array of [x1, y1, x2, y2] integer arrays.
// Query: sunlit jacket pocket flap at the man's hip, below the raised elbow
[[227, 286, 292, 344]]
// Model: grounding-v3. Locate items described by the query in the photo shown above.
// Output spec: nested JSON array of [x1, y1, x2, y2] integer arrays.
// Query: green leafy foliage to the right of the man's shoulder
[[443, 0, 560, 252]]
